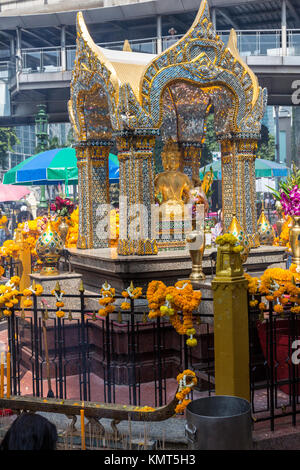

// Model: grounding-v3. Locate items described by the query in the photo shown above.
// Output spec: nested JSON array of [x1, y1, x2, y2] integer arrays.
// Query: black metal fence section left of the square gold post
[[4, 290, 214, 406]]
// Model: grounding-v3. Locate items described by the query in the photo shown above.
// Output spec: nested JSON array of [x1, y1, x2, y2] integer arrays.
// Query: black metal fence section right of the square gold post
[[249, 292, 300, 431]]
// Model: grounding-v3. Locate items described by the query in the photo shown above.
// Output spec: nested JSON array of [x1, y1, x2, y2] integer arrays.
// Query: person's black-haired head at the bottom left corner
[[0, 413, 57, 450]]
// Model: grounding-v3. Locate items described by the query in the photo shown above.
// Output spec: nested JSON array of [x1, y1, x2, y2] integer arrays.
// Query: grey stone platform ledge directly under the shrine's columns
[[69, 246, 286, 293]]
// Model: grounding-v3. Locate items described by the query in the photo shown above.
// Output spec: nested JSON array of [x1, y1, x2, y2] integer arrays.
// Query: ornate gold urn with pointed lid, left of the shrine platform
[[35, 217, 64, 276]]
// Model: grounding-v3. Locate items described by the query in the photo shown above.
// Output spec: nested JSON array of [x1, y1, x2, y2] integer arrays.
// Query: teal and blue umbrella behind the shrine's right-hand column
[[200, 158, 289, 180]]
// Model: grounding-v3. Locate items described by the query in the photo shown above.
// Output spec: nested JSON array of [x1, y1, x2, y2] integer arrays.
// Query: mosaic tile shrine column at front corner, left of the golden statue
[[117, 130, 157, 255]]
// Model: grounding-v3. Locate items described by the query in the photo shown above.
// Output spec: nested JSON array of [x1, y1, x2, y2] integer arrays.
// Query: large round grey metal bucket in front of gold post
[[185, 395, 252, 450]]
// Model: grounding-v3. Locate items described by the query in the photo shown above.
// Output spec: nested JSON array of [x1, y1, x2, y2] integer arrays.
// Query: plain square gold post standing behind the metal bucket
[[212, 244, 250, 401]]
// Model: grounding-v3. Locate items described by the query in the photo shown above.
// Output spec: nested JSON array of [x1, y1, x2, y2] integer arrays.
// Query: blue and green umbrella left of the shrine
[[3, 147, 119, 185]]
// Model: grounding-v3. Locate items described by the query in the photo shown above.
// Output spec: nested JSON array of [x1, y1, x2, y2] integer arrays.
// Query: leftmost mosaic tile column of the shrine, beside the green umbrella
[[76, 141, 112, 249]]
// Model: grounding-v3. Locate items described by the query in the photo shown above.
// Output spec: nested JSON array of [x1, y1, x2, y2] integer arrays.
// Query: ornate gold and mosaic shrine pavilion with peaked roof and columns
[[69, 0, 267, 255]]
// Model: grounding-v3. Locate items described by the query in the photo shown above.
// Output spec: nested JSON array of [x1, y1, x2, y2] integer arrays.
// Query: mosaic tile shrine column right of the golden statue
[[221, 139, 259, 247]]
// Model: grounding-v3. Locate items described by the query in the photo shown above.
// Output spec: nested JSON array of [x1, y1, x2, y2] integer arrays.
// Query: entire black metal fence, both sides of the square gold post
[[0, 258, 300, 430]]
